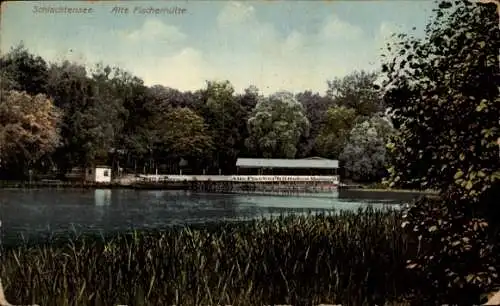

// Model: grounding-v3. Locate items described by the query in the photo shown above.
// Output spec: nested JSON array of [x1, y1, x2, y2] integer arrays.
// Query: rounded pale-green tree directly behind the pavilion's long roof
[[246, 92, 310, 158]]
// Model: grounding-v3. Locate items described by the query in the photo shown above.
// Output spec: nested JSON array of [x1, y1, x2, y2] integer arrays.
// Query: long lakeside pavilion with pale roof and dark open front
[[236, 157, 339, 176]]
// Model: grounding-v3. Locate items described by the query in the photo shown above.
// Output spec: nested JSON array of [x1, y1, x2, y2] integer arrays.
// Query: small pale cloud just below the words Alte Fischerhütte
[[121, 19, 186, 43]]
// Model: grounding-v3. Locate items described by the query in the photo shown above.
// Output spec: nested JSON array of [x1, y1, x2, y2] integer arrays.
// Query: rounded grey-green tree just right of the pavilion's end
[[339, 117, 393, 181]]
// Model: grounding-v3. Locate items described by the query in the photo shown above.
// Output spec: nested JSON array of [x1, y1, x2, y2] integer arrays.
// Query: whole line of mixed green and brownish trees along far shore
[[0, 44, 392, 180]]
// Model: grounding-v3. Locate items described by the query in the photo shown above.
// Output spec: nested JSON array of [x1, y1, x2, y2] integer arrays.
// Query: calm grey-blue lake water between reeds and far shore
[[0, 189, 401, 245]]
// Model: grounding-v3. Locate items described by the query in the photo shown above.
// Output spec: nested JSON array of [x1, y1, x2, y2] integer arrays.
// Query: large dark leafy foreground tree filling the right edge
[[383, 1, 500, 305]]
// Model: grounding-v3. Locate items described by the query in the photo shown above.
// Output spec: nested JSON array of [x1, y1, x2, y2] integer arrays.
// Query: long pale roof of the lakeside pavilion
[[236, 158, 339, 169]]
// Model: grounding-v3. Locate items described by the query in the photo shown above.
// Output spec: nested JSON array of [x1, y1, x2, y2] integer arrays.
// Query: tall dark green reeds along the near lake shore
[[0, 209, 410, 306]]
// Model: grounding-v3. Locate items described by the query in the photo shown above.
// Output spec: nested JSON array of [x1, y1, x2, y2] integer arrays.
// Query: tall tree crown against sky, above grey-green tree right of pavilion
[[327, 71, 385, 116]]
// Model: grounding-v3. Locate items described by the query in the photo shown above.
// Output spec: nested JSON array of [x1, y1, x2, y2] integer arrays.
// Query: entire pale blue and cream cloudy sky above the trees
[[0, 0, 435, 94]]
